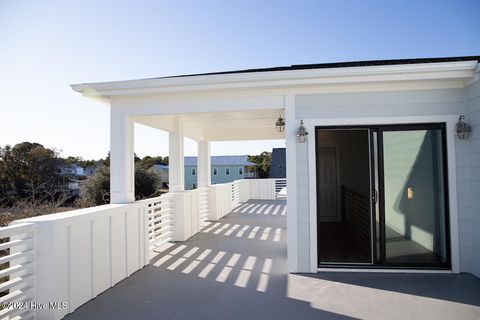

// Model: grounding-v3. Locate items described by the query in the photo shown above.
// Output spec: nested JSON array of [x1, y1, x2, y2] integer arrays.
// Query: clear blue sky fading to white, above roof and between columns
[[0, 0, 480, 159]]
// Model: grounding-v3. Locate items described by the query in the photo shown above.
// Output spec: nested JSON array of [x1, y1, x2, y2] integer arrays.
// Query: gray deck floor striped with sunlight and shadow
[[66, 201, 480, 320]]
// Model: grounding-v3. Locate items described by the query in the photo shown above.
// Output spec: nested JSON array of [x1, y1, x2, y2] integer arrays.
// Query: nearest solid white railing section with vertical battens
[[7, 200, 155, 319]]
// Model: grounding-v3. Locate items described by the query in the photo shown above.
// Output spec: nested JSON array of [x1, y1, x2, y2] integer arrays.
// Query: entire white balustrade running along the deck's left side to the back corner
[[0, 179, 285, 319]]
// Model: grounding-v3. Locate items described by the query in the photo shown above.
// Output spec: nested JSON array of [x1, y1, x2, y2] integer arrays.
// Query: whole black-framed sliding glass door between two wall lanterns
[[316, 124, 450, 268]]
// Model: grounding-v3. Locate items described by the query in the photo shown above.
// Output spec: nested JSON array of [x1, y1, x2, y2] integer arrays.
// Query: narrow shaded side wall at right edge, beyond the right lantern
[[459, 73, 480, 277]]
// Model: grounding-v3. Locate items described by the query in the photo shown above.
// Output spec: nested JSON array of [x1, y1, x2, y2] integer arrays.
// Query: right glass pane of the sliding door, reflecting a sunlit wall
[[383, 129, 447, 265]]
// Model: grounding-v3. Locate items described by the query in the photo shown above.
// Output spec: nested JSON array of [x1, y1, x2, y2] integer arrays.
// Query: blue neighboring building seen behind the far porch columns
[[185, 155, 256, 190]]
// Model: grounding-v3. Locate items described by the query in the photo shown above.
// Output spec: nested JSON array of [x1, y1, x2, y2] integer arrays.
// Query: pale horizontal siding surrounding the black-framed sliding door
[[295, 87, 472, 275]]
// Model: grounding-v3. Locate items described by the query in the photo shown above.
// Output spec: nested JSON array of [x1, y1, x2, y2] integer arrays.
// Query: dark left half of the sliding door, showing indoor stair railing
[[316, 129, 372, 264]]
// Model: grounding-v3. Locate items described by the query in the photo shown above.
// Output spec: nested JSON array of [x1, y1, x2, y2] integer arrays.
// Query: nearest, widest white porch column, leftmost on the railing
[[110, 111, 135, 203]]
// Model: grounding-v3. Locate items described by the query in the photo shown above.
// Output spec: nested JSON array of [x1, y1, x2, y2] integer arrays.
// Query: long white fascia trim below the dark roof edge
[[71, 60, 478, 97]]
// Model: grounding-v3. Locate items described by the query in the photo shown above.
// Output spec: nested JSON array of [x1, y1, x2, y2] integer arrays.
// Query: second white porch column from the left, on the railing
[[168, 117, 185, 192]]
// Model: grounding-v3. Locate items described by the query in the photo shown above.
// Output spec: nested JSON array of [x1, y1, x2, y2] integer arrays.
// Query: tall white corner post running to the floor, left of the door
[[285, 95, 298, 272]]
